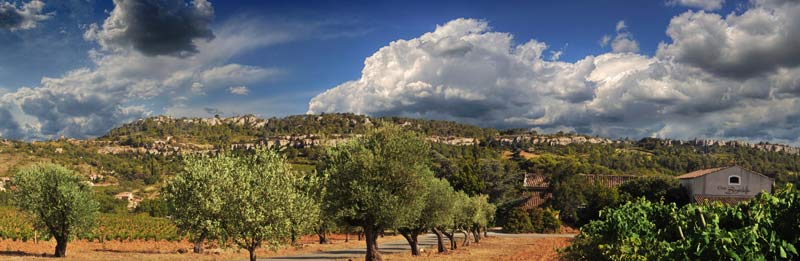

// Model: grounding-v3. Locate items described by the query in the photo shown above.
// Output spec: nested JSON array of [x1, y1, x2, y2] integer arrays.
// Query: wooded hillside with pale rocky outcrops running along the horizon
[[0, 114, 800, 203]]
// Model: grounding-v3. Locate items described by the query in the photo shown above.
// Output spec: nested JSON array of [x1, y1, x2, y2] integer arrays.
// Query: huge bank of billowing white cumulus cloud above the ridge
[[308, 14, 800, 143]]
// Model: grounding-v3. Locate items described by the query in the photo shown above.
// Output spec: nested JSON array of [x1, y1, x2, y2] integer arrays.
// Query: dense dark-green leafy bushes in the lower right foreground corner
[[562, 185, 800, 260]]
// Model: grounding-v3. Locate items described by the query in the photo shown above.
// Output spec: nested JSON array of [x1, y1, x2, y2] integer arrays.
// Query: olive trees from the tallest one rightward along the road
[[320, 125, 495, 260]]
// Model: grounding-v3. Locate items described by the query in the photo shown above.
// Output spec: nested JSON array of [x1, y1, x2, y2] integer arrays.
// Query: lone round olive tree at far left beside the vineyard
[[14, 164, 99, 257]]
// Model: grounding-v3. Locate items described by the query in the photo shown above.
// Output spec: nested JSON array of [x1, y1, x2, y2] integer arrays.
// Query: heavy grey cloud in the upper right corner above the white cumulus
[[658, 0, 800, 79]]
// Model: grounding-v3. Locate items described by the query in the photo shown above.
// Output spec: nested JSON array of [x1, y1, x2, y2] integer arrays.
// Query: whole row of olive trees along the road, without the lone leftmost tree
[[162, 125, 495, 260]]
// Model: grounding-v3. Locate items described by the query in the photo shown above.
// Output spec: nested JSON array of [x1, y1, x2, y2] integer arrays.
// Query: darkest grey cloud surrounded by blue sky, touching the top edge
[[86, 0, 214, 57]]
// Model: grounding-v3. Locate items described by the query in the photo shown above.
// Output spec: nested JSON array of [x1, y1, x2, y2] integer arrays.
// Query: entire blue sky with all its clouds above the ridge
[[0, 0, 800, 144]]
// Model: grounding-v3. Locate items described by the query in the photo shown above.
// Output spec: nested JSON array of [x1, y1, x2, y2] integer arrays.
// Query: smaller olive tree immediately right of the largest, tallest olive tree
[[398, 178, 455, 256]]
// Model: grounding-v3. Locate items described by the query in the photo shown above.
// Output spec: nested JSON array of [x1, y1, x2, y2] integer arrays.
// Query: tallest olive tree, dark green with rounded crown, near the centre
[[324, 124, 433, 260]]
